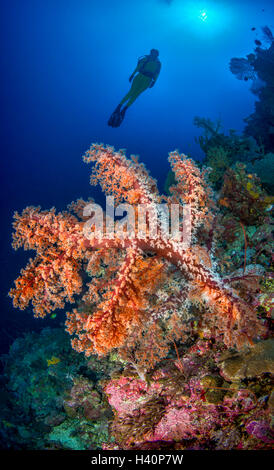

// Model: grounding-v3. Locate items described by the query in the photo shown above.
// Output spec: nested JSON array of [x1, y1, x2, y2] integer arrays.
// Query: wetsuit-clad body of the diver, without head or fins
[[120, 57, 161, 108]]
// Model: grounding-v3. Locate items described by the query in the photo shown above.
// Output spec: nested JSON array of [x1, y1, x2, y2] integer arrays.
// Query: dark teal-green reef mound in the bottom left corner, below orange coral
[[0, 328, 117, 450]]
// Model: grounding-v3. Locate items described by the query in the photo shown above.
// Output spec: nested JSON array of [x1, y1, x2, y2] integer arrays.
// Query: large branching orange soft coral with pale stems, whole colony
[[10, 144, 262, 355]]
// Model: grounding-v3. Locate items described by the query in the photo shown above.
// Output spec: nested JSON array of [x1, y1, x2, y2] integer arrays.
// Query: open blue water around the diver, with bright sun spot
[[0, 0, 274, 351]]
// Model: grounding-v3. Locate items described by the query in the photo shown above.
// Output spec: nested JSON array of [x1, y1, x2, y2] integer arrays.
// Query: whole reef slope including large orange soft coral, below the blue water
[[7, 142, 273, 450]]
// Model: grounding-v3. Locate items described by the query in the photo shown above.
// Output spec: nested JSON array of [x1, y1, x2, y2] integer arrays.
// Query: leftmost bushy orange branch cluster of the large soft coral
[[9, 207, 85, 317]]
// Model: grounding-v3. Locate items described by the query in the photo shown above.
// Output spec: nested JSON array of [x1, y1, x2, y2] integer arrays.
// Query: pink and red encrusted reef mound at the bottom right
[[101, 340, 274, 450]]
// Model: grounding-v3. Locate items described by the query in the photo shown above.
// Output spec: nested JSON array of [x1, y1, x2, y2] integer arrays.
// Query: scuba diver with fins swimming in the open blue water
[[108, 49, 161, 127]]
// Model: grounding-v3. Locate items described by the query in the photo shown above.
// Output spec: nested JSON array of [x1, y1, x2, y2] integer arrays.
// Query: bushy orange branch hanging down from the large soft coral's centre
[[67, 247, 166, 355]]
